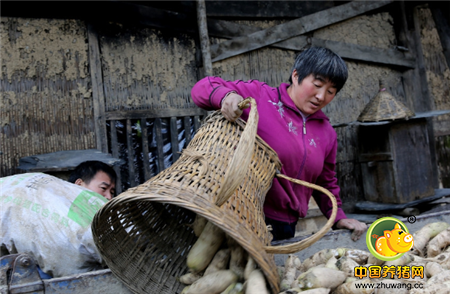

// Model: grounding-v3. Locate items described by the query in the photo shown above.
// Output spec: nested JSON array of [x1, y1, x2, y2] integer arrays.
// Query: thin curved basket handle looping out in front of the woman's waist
[[264, 173, 338, 254]]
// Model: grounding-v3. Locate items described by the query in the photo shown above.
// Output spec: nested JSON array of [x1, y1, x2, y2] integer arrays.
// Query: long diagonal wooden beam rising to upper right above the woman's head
[[211, 0, 393, 62]]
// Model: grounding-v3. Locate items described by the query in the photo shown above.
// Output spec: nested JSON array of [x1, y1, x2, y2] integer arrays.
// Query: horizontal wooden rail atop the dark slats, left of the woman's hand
[[105, 107, 206, 120]]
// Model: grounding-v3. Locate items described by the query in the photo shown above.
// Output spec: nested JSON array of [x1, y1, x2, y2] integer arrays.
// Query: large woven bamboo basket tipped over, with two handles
[[92, 99, 337, 294]]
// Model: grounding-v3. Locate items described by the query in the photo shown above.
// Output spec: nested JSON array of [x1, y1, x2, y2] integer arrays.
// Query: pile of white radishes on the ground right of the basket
[[278, 222, 450, 294]]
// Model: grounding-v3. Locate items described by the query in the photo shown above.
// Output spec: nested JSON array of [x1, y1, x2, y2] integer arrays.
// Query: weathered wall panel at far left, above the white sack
[[0, 17, 95, 177]]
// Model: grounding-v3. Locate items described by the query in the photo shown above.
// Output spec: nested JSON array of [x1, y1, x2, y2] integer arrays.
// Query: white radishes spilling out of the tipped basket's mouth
[[179, 215, 270, 294]]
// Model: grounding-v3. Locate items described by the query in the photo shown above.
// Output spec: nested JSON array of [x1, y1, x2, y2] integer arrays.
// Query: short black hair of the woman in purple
[[289, 47, 348, 92]]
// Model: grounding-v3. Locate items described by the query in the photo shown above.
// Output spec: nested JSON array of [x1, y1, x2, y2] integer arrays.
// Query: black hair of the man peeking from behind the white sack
[[68, 160, 117, 184]]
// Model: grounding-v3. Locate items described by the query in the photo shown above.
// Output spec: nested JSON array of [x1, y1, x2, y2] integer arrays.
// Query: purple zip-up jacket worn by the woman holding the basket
[[191, 77, 346, 223]]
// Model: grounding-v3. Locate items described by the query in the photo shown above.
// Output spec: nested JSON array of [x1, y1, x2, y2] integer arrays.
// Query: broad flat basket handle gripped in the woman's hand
[[216, 97, 259, 206]]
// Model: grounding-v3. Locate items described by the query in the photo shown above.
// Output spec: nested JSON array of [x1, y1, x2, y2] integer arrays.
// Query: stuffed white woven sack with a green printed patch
[[0, 173, 107, 277]]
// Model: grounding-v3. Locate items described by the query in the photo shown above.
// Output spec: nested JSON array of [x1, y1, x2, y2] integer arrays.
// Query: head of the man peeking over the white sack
[[69, 160, 117, 200]]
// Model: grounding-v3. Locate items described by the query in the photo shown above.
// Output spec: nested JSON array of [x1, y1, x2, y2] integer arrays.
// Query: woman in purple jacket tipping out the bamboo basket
[[191, 47, 367, 240]]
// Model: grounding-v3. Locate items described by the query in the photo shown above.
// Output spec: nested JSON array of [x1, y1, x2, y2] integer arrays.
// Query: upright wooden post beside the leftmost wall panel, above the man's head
[[87, 23, 108, 153]]
